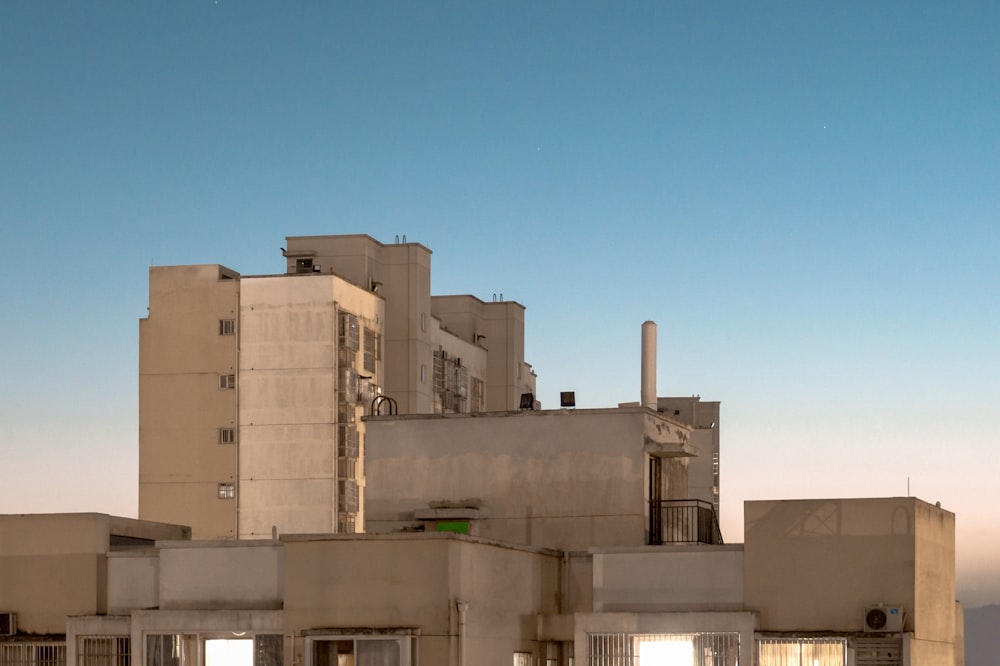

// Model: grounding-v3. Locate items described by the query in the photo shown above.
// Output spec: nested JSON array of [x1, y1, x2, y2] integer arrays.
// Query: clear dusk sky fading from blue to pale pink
[[0, 0, 1000, 606]]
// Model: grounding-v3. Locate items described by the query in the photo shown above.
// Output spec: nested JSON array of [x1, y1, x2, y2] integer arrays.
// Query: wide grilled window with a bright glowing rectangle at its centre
[[587, 631, 740, 666]]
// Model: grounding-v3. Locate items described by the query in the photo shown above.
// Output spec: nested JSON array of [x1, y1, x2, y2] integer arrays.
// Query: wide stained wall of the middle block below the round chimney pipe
[[366, 409, 689, 550]]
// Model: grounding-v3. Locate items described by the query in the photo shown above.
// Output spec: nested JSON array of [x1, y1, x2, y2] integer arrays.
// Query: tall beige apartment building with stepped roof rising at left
[[139, 235, 535, 538]]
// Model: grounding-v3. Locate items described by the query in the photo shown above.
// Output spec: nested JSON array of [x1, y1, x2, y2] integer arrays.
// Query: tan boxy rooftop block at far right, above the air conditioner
[[744, 497, 955, 641]]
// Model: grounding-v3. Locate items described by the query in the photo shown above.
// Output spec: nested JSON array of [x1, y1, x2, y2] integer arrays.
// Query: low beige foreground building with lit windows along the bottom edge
[[0, 497, 963, 666]]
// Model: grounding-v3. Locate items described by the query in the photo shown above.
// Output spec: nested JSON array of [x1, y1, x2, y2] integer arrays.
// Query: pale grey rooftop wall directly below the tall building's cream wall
[[159, 541, 284, 610]]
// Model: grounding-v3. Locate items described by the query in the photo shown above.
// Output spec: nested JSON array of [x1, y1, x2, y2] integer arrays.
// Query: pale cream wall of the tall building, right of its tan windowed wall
[[238, 274, 383, 538]]
